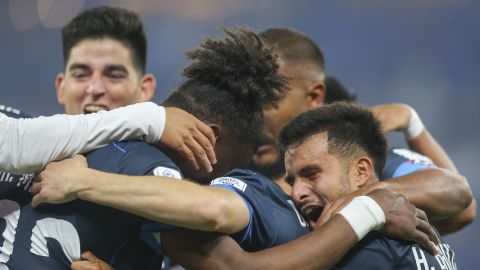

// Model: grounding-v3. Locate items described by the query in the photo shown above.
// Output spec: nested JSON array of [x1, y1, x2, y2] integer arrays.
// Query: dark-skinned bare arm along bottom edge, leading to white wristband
[[162, 215, 357, 270]]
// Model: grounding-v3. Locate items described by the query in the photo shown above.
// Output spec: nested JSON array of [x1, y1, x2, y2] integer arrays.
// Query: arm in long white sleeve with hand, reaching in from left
[[0, 102, 215, 173]]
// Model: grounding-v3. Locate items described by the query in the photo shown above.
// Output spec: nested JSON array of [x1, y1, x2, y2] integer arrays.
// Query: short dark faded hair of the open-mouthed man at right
[[280, 102, 387, 177]]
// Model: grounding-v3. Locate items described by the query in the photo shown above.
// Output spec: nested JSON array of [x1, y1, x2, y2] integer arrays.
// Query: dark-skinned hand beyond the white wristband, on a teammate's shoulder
[[368, 189, 440, 254]]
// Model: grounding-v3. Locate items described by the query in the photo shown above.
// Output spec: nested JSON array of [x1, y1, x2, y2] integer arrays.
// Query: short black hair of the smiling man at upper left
[[62, 6, 147, 73]]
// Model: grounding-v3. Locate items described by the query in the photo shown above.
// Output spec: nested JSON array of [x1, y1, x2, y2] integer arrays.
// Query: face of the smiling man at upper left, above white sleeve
[[56, 38, 154, 114]]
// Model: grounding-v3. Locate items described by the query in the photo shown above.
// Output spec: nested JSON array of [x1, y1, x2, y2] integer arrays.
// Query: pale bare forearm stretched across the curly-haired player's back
[[74, 169, 248, 233]]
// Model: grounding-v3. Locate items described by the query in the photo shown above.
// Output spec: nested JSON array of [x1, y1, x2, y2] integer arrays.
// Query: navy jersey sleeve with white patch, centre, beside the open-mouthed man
[[210, 169, 309, 251]]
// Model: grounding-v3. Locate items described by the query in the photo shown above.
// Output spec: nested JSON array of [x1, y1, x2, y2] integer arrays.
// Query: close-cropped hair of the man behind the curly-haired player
[[260, 28, 325, 73]]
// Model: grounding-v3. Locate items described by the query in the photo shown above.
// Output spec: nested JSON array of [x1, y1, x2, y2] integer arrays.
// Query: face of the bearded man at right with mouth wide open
[[285, 132, 355, 228]]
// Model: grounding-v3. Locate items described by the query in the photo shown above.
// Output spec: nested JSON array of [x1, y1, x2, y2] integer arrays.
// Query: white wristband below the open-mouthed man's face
[[339, 196, 385, 241]]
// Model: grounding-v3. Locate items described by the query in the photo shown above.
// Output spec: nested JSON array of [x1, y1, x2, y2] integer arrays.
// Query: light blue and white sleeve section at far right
[[381, 148, 435, 180]]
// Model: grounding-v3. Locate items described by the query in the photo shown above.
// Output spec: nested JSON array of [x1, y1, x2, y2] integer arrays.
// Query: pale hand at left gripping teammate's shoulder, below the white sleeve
[[31, 155, 87, 207]]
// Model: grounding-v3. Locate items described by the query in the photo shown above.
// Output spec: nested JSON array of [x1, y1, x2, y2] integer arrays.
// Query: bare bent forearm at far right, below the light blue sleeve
[[382, 169, 472, 220]]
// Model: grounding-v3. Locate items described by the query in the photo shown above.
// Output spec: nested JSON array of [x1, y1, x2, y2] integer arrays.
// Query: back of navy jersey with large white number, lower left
[[2, 141, 179, 270]]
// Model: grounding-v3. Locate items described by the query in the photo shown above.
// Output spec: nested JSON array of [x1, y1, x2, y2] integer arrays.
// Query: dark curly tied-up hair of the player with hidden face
[[163, 28, 286, 150]]
